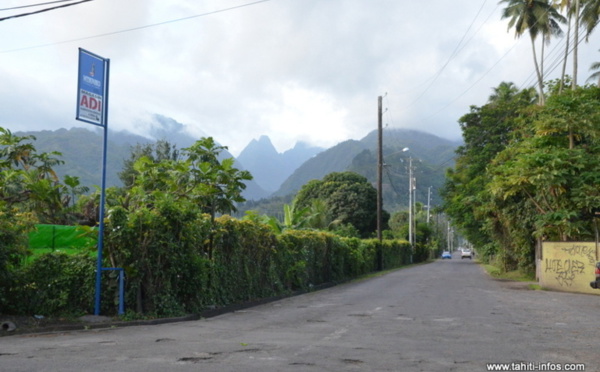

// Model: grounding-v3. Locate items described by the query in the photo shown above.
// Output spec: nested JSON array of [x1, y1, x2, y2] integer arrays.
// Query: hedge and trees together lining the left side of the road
[[0, 128, 440, 319]]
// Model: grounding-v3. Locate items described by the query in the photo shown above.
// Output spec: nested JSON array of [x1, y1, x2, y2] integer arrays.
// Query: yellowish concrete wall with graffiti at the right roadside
[[537, 242, 600, 295]]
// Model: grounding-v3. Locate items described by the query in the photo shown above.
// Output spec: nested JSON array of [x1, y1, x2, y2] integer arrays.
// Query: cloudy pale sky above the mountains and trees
[[0, 0, 600, 156]]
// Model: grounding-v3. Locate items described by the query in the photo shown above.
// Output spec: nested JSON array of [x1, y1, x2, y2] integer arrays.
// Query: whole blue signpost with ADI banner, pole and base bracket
[[76, 48, 124, 315]]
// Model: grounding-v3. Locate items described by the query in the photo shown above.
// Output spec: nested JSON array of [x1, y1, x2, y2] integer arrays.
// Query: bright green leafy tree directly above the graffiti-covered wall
[[489, 87, 600, 240]]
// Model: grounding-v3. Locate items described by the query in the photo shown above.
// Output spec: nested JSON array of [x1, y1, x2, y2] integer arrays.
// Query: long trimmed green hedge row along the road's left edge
[[0, 217, 419, 317]]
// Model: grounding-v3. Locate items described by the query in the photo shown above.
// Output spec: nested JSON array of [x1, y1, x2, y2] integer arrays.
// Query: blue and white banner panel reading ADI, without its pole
[[76, 48, 108, 126]]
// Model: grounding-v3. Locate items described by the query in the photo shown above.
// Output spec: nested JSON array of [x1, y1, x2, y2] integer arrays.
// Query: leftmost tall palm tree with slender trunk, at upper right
[[500, 0, 565, 105]]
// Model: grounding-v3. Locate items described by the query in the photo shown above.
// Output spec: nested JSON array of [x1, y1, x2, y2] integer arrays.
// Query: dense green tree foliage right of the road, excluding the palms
[[443, 87, 600, 271]]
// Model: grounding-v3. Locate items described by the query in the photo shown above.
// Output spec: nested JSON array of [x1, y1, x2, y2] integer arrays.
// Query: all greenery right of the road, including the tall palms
[[442, 0, 600, 275]]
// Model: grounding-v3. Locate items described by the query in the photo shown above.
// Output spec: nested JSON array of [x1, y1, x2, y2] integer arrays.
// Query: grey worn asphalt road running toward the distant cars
[[0, 253, 600, 372]]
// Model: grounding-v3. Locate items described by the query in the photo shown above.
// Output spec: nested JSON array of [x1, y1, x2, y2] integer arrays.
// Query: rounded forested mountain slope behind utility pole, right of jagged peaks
[[273, 129, 461, 208]]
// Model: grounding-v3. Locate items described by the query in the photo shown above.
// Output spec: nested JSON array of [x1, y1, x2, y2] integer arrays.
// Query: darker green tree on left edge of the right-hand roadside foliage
[[441, 83, 535, 266]]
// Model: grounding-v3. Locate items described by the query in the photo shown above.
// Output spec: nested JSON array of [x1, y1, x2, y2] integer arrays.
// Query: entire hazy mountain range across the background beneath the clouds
[[15, 115, 460, 209]]
